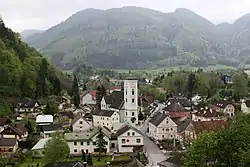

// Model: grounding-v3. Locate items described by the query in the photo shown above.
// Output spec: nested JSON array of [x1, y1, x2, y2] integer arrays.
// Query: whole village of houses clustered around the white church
[[0, 71, 250, 167]]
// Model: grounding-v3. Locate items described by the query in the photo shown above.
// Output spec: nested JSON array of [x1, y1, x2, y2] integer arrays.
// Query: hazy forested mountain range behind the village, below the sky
[[24, 7, 250, 70]]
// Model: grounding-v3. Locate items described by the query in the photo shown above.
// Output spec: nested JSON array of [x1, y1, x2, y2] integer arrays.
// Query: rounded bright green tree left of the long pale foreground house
[[44, 133, 69, 164]]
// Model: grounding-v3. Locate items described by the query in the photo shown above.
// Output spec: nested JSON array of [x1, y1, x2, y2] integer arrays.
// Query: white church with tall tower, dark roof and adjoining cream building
[[93, 79, 139, 130]]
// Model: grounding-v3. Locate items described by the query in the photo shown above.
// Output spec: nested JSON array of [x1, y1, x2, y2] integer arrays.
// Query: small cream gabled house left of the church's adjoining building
[[71, 115, 91, 132]]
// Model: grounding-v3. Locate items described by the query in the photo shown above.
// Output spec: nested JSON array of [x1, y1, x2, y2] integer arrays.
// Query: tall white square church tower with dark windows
[[124, 79, 138, 125]]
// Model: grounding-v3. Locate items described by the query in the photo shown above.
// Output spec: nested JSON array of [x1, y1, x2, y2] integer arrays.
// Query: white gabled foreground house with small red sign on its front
[[116, 124, 144, 153]]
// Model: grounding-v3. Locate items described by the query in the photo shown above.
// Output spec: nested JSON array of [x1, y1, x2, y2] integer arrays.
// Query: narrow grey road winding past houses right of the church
[[140, 105, 167, 167]]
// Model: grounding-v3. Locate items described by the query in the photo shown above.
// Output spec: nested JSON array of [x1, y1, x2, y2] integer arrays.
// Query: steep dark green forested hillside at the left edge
[[0, 17, 70, 101]]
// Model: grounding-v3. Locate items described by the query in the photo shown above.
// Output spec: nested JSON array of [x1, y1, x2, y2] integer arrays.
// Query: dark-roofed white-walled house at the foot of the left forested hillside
[[14, 99, 41, 113]]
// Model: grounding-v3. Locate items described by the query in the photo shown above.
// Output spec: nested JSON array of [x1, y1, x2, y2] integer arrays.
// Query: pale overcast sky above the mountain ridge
[[0, 0, 250, 32]]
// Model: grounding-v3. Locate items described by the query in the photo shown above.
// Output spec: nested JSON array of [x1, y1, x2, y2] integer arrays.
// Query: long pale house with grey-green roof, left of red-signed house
[[65, 128, 111, 156]]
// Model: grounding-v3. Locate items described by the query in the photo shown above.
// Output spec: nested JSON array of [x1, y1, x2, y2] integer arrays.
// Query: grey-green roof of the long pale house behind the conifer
[[64, 128, 111, 141]]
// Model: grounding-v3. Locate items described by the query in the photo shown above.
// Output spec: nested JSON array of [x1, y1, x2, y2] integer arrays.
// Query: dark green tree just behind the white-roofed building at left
[[44, 96, 59, 116]]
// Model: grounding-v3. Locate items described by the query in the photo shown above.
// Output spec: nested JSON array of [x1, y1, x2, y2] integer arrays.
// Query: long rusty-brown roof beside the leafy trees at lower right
[[192, 120, 228, 138]]
